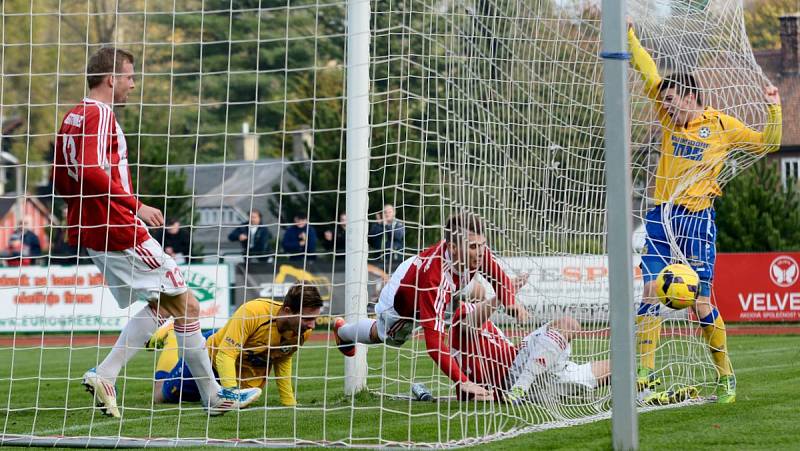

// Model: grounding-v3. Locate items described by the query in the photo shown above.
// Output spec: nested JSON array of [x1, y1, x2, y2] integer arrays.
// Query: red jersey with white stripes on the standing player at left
[[53, 98, 150, 252]]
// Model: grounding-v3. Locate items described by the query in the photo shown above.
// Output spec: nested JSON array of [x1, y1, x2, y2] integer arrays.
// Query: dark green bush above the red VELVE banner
[[716, 159, 800, 252]]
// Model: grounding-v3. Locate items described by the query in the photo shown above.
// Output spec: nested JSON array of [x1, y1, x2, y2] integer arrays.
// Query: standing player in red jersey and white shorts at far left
[[53, 47, 261, 417]]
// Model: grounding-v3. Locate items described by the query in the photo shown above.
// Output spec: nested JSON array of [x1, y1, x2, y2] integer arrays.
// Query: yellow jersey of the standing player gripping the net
[[628, 29, 782, 211]]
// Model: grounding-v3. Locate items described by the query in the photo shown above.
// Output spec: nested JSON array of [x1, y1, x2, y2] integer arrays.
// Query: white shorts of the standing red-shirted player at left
[[88, 238, 187, 308]]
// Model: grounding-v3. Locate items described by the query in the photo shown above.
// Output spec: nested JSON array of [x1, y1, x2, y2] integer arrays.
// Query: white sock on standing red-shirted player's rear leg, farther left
[[95, 305, 163, 384]]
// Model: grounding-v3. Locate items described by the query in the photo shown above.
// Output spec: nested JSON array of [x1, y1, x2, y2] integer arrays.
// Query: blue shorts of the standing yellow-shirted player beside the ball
[[641, 204, 717, 296]]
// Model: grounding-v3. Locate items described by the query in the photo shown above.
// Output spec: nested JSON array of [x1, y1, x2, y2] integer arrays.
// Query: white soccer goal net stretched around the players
[[0, 0, 772, 447]]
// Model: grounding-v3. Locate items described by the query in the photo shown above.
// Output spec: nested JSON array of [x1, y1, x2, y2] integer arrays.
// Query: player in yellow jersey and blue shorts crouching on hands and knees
[[148, 285, 322, 406]]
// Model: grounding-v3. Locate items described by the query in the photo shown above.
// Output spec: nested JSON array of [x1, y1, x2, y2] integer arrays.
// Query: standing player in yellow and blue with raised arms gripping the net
[[628, 24, 781, 403]]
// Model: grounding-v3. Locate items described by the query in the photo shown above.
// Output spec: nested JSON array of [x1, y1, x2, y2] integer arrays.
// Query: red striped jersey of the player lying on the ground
[[450, 302, 517, 388]]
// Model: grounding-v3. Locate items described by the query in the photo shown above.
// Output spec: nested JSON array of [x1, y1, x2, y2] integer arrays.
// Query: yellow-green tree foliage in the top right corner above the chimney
[[744, 0, 800, 50]]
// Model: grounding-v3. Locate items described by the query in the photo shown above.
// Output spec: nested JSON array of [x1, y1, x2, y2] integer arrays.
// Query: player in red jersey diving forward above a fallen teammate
[[334, 213, 524, 399]]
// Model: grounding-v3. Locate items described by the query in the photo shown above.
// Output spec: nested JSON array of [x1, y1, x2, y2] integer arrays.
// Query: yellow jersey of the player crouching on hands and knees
[[206, 299, 311, 406]]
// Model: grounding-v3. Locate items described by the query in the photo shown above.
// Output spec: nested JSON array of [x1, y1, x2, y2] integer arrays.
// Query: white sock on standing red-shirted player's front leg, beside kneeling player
[[174, 321, 220, 406]]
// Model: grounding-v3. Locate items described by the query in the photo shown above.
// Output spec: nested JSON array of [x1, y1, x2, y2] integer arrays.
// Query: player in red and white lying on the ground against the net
[[450, 284, 610, 402]]
